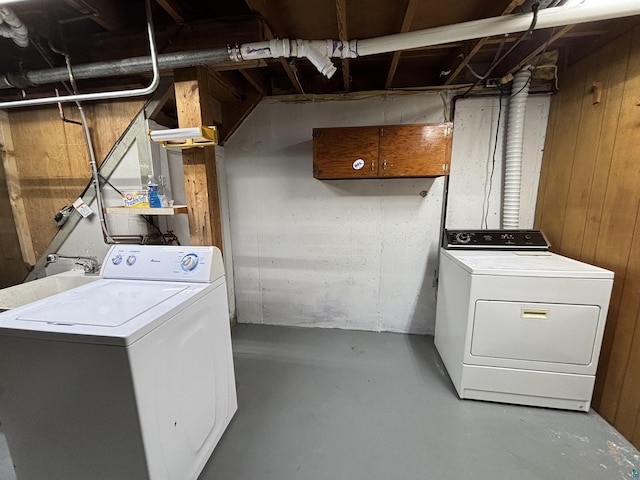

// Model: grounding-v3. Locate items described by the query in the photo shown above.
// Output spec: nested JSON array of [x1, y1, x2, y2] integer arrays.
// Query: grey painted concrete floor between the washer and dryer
[[0, 325, 640, 480]]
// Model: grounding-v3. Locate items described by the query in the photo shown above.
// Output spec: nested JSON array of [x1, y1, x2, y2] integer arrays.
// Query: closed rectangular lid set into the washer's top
[[15, 281, 188, 328]]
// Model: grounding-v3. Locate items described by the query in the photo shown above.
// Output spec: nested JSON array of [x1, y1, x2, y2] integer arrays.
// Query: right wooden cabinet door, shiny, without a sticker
[[380, 123, 453, 177]]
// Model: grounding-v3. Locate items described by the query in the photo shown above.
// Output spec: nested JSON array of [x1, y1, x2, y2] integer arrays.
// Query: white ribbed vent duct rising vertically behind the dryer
[[502, 68, 531, 229]]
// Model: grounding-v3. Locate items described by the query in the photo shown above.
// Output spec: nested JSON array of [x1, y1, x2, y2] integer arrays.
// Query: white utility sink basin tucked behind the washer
[[0, 270, 100, 311]]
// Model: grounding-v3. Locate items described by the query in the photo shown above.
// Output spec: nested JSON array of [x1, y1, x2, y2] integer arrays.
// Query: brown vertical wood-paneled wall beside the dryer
[[535, 27, 640, 447]]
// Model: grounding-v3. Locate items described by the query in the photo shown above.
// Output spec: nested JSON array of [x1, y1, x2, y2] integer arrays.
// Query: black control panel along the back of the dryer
[[442, 229, 549, 250]]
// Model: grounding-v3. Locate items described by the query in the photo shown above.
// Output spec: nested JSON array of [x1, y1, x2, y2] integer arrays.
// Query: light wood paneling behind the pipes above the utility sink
[[0, 99, 144, 266]]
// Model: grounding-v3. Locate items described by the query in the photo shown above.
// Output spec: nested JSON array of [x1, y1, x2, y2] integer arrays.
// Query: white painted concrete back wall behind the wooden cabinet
[[225, 94, 549, 333]]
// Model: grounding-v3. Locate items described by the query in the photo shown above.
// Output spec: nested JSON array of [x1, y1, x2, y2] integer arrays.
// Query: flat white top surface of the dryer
[[440, 249, 613, 278]]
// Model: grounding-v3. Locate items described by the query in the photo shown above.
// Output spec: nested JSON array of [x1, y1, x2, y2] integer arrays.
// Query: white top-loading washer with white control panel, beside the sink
[[0, 245, 237, 480]]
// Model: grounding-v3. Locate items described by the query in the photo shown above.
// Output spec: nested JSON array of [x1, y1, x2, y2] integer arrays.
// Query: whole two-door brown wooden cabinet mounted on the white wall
[[313, 123, 453, 180]]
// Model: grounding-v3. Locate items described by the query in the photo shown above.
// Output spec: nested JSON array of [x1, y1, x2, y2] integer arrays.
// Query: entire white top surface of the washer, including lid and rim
[[0, 276, 218, 346]]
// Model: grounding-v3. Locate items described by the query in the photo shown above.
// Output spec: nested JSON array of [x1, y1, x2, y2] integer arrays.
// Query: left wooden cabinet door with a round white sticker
[[313, 127, 380, 179]]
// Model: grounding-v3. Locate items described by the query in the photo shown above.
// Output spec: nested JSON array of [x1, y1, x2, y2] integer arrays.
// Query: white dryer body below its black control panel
[[435, 249, 613, 411]]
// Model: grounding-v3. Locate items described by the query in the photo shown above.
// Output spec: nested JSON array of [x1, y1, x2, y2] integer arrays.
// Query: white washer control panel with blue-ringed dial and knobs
[[102, 245, 224, 282]]
